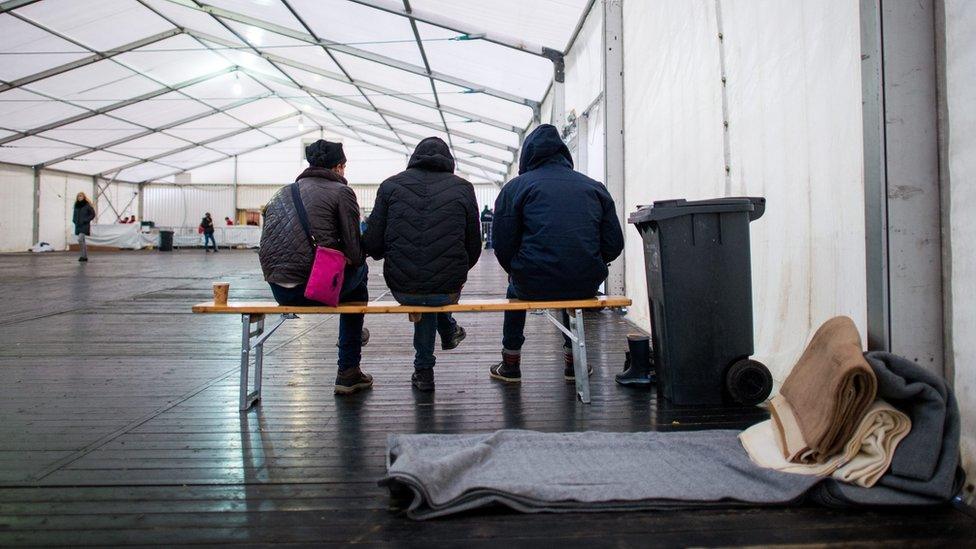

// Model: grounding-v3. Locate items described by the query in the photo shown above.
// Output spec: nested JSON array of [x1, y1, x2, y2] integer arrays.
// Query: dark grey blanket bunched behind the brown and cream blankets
[[811, 352, 962, 505]]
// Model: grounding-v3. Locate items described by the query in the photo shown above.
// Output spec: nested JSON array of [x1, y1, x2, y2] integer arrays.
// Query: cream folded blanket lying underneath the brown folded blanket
[[739, 400, 912, 488]]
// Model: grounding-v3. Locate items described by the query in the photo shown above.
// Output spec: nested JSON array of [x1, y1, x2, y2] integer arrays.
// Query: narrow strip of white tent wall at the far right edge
[[943, 0, 976, 500]]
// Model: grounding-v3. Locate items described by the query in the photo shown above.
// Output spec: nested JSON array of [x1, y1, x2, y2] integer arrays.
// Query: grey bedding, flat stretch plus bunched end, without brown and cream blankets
[[381, 352, 963, 519]]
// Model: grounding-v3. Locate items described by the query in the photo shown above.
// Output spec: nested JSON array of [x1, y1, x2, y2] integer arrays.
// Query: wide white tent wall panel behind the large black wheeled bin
[[624, 0, 866, 382]]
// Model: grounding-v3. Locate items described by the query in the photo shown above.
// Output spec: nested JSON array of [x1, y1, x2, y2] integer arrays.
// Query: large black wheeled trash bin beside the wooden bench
[[629, 197, 772, 405]]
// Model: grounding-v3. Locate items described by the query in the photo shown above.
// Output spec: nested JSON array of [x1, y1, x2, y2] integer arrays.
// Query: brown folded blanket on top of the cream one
[[770, 316, 878, 463]]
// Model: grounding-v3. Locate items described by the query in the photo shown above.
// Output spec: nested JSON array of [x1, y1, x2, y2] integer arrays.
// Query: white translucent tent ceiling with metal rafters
[[0, 0, 593, 182]]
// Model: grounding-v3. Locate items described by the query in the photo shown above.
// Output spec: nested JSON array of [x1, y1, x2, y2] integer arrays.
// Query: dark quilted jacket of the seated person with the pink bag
[[258, 168, 365, 284]]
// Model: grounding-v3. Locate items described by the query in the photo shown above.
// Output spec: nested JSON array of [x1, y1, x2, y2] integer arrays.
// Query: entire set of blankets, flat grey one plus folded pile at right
[[381, 319, 963, 520]]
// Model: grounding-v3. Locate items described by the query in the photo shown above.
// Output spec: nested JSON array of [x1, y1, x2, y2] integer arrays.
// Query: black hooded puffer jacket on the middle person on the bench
[[363, 137, 481, 294]]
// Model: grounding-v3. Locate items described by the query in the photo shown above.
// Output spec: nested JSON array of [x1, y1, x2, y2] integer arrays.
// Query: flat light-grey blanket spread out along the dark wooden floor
[[383, 430, 819, 519]]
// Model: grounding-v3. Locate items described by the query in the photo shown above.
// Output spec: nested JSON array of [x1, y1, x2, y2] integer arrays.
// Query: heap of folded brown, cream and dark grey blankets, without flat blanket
[[739, 317, 959, 504]]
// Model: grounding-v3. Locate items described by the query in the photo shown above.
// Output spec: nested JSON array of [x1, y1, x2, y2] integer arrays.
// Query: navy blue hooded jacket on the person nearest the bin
[[492, 124, 624, 300]]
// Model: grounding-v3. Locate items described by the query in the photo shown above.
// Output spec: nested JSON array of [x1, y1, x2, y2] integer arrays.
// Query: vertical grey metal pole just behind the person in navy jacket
[[603, 2, 627, 295]]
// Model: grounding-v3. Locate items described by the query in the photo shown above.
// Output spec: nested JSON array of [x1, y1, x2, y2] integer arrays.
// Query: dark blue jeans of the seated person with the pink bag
[[268, 264, 369, 372]]
